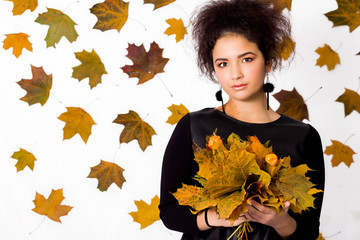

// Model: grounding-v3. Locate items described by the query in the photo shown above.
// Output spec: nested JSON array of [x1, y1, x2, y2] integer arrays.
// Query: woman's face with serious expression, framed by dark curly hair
[[212, 33, 271, 101]]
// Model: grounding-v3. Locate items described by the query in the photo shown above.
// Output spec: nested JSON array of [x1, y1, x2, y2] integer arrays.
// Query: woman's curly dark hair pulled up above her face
[[192, 0, 291, 82]]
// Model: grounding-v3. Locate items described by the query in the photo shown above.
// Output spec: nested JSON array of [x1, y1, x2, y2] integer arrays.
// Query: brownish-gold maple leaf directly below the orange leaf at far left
[[17, 65, 52, 106]]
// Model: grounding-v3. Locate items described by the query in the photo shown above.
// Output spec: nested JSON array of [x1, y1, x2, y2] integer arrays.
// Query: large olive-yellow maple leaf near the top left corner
[[35, 8, 78, 47]]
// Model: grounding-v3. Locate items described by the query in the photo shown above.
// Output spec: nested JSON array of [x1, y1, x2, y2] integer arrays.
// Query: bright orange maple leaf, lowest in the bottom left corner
[[32, 189, 73, 222]]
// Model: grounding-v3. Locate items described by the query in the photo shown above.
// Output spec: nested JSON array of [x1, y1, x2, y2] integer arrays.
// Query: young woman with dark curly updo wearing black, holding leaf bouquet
[[159, 0, 324, 240]]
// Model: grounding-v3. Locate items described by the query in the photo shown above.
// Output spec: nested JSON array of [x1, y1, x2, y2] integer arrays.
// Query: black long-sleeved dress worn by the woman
[[159, 108, 325, 240]]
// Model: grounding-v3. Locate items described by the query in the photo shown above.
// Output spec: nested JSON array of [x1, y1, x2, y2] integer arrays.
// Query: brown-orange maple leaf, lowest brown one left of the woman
[[88, 160, 126, 192]]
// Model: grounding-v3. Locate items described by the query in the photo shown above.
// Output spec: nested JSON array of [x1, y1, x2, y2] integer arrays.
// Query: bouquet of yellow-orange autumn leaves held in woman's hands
[[173, 133, 321, 239]]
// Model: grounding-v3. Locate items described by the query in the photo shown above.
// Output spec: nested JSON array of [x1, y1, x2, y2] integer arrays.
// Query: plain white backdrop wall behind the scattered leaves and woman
[[0, 0, 360, 240]]
